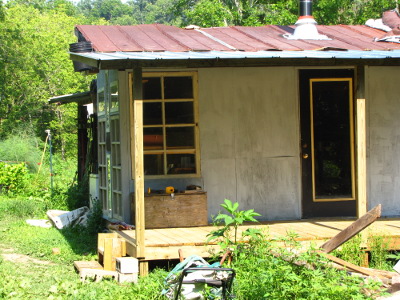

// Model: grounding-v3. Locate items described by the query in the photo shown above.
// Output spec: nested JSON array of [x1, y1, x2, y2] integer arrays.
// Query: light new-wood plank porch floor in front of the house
[[120, 218, 400, 261]]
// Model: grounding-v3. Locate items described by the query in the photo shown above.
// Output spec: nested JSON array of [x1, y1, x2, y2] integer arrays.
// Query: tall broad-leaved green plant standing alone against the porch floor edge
[[207, 199, 261, 250]]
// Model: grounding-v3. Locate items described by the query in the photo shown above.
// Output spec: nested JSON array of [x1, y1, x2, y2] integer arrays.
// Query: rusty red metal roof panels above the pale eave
[[76, 24, 400, 52]]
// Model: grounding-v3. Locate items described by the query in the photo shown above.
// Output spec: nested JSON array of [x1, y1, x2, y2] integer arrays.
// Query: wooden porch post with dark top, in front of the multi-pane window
[[132, 67, 147, 275]]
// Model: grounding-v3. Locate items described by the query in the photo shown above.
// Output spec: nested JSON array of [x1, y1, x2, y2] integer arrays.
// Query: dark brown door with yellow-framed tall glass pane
[[299, 69, 356, 218]]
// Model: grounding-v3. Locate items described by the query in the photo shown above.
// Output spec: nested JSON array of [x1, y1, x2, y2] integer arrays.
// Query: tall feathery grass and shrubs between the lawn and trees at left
[[0, 130, 89, 210]]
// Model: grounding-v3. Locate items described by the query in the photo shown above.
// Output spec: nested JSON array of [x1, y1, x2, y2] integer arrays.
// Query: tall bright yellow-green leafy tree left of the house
[[0, 1, 91, 155]]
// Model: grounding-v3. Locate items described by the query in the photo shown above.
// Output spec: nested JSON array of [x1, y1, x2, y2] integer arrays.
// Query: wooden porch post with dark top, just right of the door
[[356, 66, 367, 218]]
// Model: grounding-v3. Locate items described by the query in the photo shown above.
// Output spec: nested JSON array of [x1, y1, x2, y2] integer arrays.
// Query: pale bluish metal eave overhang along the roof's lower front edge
[[70, 50, 400, 70]]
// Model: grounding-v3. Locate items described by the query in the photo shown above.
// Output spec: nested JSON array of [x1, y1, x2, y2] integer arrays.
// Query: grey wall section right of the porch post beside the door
[[366, 67, 400, 216]]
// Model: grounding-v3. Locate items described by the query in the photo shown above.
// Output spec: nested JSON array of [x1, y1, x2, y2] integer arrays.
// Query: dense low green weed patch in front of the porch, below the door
[[232, 237, 377, 299]]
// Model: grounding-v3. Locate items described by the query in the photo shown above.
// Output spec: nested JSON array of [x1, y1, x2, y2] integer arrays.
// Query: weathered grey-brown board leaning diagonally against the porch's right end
[[321, 204, 381, 253]]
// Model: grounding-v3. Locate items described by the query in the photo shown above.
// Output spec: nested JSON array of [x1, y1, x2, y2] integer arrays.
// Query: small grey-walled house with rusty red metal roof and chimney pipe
[[70, 1, 400, 229]]
